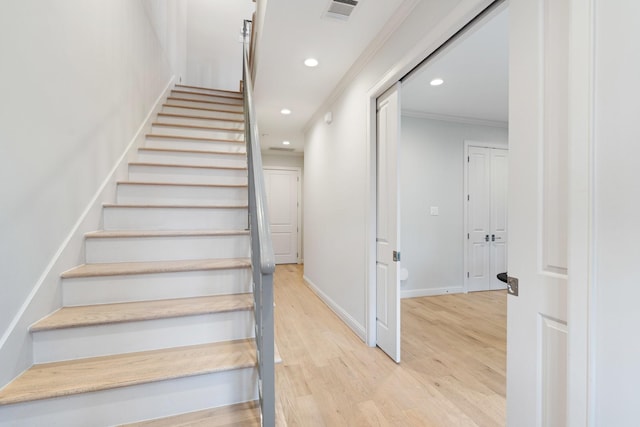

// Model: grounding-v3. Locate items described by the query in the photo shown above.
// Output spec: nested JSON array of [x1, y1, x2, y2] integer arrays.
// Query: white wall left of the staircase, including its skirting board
[[0, 0, 178, 386]]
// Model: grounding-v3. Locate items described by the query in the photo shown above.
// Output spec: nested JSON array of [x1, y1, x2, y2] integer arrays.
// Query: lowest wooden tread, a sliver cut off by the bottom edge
[[121, 400, 261, 427]]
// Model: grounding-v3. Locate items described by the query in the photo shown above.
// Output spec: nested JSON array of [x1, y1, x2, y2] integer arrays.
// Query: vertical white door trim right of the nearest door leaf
[[567, 0, 598, 427]]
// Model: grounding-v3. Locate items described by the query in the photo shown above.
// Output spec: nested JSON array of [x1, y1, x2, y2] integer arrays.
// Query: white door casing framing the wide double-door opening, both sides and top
[[364, 0, 596, 427]]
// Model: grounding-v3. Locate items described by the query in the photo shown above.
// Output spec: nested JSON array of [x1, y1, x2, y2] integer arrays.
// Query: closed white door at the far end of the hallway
[[264, 168, 300, 264]]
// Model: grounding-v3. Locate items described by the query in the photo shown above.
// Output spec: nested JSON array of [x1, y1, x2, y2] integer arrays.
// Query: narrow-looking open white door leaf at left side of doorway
[[376, 82, 401, 363]]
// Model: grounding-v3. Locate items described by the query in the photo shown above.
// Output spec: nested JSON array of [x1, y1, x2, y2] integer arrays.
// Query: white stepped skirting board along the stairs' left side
[[0, 76, 175, 388]]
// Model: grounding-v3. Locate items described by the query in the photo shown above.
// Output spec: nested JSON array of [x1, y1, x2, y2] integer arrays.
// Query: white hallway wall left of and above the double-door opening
[[304, 0, 489, 338]]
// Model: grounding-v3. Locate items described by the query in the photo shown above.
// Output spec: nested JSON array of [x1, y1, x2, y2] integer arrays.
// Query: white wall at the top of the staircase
[[186, 0, 255, 91]]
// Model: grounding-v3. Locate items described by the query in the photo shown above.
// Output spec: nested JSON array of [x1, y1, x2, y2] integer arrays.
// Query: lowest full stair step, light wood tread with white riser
[[0, 340, 257, 427]]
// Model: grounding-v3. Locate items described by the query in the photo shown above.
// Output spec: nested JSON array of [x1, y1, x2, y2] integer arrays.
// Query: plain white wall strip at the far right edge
[[592, 1, 640, 426]]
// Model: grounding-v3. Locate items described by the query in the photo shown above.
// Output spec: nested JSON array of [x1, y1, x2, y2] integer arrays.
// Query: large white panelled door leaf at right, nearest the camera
[[507, 0, 571, 427]]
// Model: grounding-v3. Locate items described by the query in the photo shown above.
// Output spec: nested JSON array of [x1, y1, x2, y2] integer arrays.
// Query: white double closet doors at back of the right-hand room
[[466, 145, 508, 292]]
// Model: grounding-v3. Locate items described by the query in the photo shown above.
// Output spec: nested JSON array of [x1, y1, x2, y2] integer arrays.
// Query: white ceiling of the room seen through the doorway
[[402, 9, 509, 125]]
